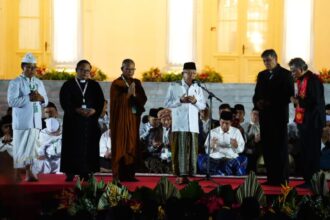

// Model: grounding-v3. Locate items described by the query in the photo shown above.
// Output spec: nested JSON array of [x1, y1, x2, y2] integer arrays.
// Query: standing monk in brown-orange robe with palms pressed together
[[110, 59, 147, 181]]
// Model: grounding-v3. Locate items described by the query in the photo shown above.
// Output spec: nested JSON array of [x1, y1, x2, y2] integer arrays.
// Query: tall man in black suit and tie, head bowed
[[253, 49, 294, 185]]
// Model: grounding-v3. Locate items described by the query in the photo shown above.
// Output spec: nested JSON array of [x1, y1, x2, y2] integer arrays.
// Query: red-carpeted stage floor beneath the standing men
[[0, 173, 320, 195]]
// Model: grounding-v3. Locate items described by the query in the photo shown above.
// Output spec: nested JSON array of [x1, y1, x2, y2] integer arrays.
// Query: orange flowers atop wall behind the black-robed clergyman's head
[[36, 65, 107, 81]]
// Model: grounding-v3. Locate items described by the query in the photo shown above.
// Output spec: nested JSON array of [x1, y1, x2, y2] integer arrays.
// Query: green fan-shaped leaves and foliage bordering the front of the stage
[[56, 172, 330, 219]]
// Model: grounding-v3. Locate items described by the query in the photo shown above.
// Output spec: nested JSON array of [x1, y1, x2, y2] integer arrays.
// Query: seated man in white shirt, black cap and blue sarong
[[198, 111, 247, 175]]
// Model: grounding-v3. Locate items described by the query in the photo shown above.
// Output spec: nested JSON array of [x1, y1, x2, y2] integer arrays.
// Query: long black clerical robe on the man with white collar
[[60, 79, 104, 174]]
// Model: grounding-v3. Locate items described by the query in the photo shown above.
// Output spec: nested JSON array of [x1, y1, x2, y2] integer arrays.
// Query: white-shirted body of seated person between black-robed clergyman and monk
[[100, 129, 111, 172]]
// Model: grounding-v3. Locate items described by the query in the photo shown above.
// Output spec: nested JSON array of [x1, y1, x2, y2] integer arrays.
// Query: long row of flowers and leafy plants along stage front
[[43, 172, 330, 220]]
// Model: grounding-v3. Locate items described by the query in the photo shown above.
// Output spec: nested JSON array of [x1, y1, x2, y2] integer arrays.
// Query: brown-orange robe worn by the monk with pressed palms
[[110, 77, 147, 177]]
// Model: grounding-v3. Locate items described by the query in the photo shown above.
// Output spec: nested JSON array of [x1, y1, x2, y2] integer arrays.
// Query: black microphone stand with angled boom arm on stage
[[195, 81, 222, 180]]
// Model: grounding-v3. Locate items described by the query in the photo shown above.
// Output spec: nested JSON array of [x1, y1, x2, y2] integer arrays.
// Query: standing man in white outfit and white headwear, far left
[[7, 53, 48, 181]]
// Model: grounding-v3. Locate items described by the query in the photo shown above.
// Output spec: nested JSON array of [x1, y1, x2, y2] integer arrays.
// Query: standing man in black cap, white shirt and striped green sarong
[[165, 62, 205, 184]]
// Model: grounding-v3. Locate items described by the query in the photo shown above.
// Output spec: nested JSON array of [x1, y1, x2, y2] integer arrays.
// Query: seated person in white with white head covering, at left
[[32, 117, 62, 175]]
